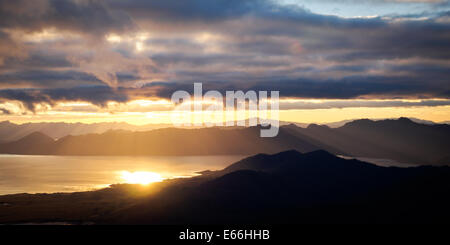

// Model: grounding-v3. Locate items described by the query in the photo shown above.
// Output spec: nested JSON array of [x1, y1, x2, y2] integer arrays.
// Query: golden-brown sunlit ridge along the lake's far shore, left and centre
[[0, 127, 318, 155]]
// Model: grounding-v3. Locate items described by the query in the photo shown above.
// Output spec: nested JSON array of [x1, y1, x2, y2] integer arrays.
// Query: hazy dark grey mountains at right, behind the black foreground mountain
[[291, 118, 450, 164]]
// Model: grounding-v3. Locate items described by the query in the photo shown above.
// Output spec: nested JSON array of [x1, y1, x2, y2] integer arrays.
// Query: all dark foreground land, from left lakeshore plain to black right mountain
[[0, 150, 450, 224]]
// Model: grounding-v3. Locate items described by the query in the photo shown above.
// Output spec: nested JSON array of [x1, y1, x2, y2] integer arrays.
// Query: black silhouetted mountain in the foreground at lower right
[[107, 151, 450, 224]]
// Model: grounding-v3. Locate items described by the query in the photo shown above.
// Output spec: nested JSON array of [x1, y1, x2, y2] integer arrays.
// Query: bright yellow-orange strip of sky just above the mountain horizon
[[0, 100, 450, 125]]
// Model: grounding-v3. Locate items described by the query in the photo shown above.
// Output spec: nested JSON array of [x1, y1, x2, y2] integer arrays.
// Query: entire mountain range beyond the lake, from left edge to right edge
[[0, 118, 450, 165]]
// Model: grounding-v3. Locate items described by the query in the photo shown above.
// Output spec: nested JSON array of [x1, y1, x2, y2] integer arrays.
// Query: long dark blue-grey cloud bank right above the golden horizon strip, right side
[[146, 72, 450, 99]]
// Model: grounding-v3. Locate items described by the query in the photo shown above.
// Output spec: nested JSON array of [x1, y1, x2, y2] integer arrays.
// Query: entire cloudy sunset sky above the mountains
[[0, 0, 450, 124]]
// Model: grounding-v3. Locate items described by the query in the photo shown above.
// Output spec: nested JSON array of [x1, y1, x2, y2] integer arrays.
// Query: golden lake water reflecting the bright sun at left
[[0, 154, 245, 195]]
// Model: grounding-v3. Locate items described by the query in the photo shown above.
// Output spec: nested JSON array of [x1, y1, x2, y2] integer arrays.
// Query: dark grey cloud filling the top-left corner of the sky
[[0, 0, 133, 37]]
